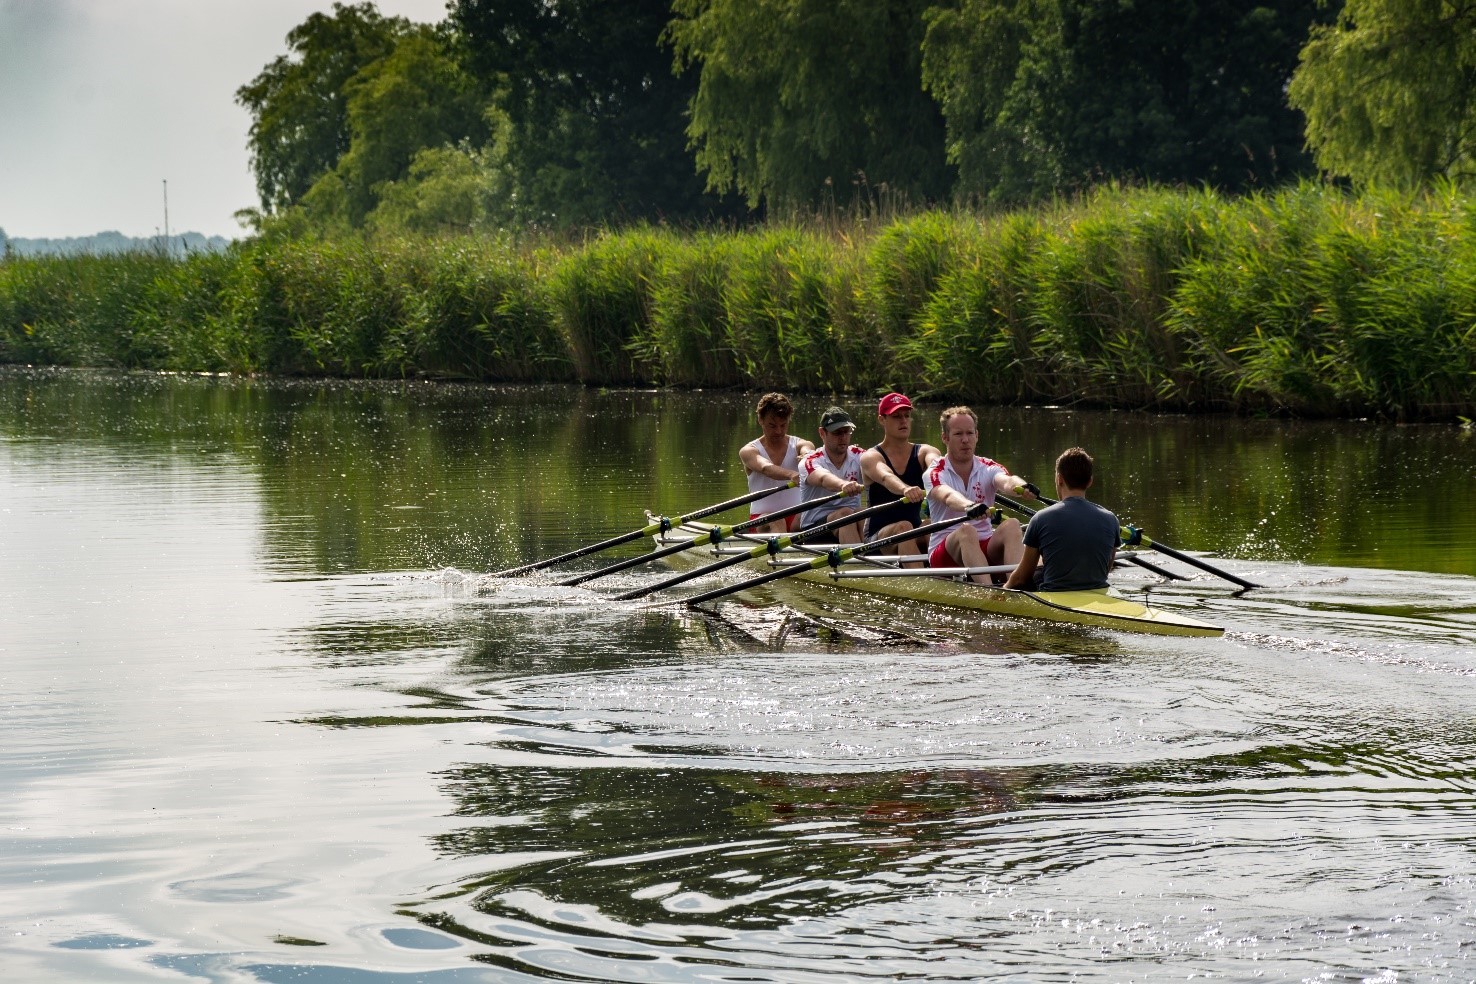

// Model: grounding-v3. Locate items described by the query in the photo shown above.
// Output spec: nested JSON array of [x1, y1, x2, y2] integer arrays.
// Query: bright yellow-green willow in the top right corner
[[1289, 0, 1476, 184]]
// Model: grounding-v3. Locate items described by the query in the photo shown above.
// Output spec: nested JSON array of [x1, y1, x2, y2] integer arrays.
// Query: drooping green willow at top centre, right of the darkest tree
[[667, 0, 951, 208]]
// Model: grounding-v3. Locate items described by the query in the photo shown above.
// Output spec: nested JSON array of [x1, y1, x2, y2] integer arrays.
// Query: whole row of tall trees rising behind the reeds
[[227, 0, 1476, 238]]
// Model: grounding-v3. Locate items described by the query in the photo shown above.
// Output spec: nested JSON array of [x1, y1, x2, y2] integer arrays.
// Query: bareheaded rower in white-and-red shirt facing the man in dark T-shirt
[[923, 407, 1035, 584]]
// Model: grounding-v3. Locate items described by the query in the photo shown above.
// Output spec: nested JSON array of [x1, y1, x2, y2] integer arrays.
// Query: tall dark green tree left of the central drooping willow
[[450, 0, 734, 227]]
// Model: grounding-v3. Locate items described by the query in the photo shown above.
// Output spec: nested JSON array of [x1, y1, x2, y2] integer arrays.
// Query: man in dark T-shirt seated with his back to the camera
[[1005, 447, 1122, 592]]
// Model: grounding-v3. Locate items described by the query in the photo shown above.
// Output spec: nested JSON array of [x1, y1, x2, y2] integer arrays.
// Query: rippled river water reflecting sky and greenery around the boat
[[0, 369, 1476, 984]]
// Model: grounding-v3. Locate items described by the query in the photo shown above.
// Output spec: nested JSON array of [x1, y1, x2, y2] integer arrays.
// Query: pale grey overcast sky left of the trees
[[0, 0, 446, 239]]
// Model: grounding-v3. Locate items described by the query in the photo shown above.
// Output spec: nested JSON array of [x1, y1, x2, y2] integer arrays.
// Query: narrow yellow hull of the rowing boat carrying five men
[[655, 524, 1225, 636]]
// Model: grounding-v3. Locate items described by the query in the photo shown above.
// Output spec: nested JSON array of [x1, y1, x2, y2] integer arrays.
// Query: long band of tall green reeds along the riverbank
[[0, 184, 1476, 419]]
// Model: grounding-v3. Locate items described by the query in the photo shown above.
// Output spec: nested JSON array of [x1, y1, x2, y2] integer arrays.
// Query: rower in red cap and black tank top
[[861, 392, 940, 567]]
